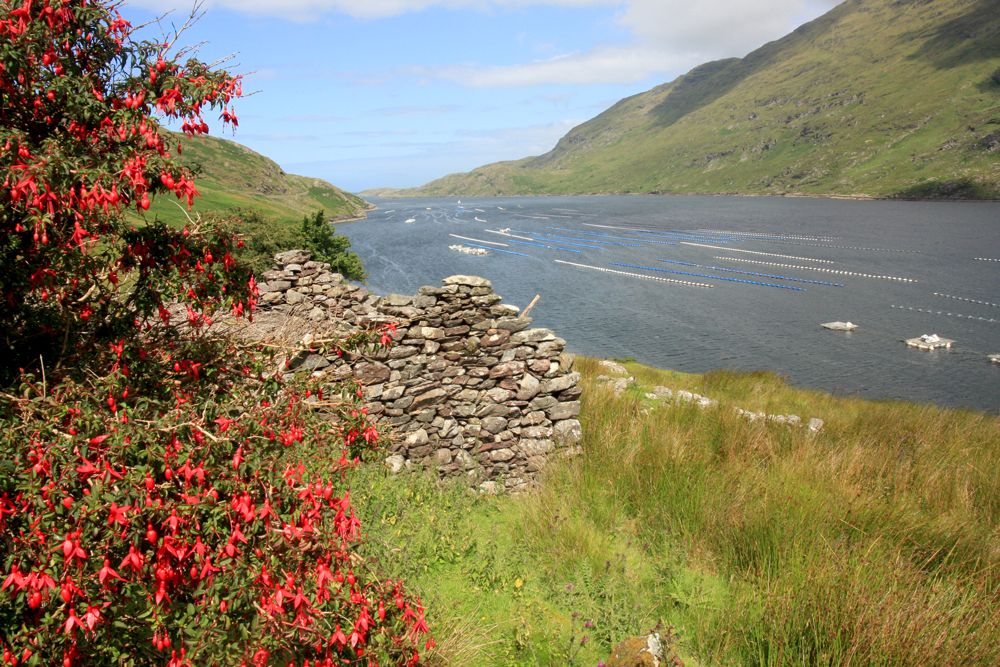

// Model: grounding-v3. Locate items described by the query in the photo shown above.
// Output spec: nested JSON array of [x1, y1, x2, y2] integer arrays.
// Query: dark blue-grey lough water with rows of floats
[[338, 196, 1000, 412]]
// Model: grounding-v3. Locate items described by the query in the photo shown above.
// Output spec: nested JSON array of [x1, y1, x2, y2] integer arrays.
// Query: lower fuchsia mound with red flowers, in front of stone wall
[[0, 334, 427, 667]]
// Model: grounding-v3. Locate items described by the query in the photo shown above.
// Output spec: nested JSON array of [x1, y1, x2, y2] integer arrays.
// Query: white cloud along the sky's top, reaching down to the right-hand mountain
[[132, 0, 839, 87]]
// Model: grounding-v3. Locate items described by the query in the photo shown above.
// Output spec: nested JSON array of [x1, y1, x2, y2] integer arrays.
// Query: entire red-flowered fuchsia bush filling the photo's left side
[[0, 0, 433, 667]]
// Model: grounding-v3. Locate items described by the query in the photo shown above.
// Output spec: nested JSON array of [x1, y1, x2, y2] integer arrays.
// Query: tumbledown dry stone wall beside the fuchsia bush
[[260, 251, 581, 491]]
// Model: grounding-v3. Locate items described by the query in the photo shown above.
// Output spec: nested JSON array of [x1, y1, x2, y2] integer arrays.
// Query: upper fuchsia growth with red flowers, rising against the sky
[[0, 0, 252, 376]]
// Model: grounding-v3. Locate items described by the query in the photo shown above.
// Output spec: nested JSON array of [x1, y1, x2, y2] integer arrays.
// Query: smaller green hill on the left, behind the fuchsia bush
[[150, 135, 370, 223]]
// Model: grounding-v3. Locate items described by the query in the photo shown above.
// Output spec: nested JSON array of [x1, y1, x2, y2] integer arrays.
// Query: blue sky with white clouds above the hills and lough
[[120, 0, 837, 192]]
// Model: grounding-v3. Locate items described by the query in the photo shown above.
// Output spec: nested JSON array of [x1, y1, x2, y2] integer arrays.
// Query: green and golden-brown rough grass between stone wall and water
[[354, 359, 1000, 666]]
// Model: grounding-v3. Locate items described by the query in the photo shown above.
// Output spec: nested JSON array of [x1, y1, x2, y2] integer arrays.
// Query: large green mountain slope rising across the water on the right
[[405, 0, 1000, 197]]
